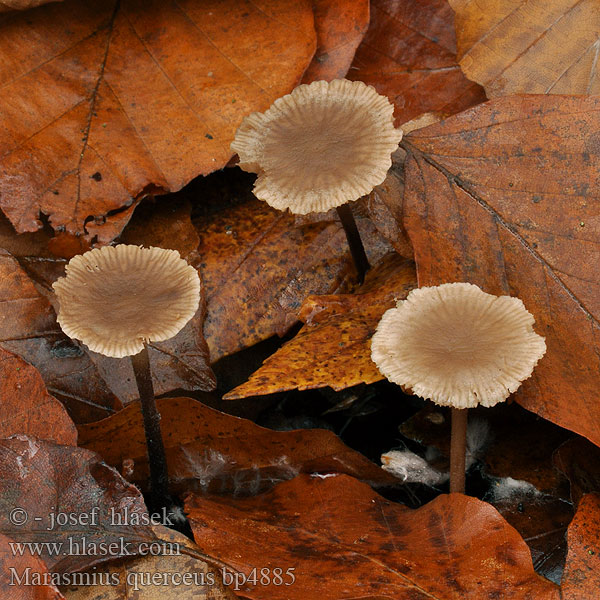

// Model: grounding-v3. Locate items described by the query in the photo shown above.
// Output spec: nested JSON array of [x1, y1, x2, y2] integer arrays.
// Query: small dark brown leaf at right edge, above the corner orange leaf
[[552, 437, 600, 506]]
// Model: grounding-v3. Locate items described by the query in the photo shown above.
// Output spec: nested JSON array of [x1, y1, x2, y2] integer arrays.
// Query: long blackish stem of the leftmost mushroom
[[131, 344, 171, 511]]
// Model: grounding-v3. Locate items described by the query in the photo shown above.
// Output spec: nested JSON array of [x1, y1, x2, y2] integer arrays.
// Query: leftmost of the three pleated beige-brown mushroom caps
[[52, 244, 200, 358]]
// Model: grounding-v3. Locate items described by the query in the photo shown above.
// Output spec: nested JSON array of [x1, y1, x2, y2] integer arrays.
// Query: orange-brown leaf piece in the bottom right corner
[[561, 494, 600, 600]]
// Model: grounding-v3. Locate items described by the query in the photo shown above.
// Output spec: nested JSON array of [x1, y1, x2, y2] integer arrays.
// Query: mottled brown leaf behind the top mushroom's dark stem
[[195, 199, 390, 362]]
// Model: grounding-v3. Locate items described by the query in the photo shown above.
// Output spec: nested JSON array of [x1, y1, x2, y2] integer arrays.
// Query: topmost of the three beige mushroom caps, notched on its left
[[231, 79, 402, 214]]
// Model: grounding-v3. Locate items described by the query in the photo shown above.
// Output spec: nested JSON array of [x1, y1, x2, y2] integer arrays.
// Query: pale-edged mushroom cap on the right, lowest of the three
[[371, 283, 546, 408]]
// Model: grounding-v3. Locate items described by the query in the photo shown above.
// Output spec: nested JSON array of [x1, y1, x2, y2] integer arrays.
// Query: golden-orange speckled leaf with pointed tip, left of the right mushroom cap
[[223, 253, 417, 400]]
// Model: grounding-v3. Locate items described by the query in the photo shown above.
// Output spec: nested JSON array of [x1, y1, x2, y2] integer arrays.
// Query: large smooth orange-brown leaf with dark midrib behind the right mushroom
[[402, 96, 600, 444]]
